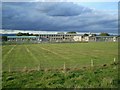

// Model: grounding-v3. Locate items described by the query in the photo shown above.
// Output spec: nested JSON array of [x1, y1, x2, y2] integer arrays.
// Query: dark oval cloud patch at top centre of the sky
[[37, 3, 92, 16]]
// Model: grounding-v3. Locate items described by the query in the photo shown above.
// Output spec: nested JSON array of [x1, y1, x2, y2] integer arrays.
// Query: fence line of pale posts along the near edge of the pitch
[[3, 58, 117, 73]]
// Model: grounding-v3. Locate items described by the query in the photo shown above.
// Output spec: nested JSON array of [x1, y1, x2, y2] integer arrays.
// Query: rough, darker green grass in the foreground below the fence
[[3, 64, 119, 88]]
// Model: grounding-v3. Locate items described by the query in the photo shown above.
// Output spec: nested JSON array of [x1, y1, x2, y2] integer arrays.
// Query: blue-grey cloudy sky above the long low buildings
[[2, 2, 118, 33]]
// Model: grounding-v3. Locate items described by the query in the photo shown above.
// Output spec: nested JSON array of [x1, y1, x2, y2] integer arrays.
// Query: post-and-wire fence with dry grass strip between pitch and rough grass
[[3, 58, 118, 72]]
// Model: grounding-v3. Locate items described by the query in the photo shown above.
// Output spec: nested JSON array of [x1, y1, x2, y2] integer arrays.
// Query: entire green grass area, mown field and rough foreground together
[[2, 42, 120, 88]]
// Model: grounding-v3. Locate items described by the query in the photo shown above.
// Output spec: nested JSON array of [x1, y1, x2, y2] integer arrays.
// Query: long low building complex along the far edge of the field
[[7, 34, 118, 42]]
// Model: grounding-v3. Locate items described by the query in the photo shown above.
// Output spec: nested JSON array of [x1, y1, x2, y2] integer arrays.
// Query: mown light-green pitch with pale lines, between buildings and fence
[[2, 42, 118, 71]]
